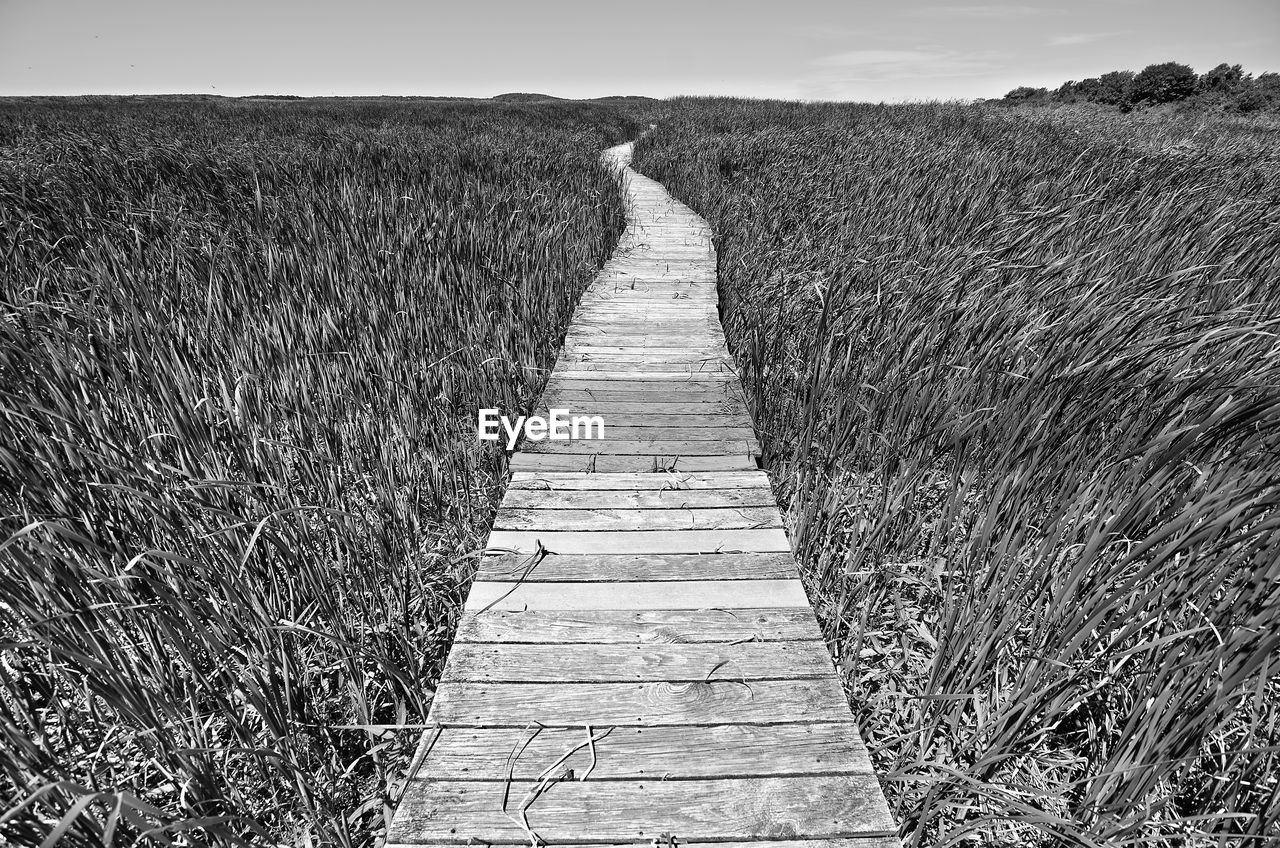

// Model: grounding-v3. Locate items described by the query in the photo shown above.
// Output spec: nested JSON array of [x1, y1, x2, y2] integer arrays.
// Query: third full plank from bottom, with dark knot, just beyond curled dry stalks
[[430, 675, 852, 728]]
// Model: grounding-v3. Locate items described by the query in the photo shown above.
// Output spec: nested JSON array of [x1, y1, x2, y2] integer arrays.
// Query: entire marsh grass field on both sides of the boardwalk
[[0, 99, 1280, 848]]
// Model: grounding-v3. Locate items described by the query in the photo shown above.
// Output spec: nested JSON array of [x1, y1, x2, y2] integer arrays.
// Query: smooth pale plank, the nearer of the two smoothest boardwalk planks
[[463, 580, 809, 611]]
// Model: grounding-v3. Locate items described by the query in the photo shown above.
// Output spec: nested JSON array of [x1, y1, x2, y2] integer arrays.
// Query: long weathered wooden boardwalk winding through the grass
[[388, 145, 899, 848]]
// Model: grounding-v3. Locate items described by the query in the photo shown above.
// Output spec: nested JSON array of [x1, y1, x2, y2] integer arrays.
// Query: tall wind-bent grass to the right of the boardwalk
[[636, 101, 1280, 845]]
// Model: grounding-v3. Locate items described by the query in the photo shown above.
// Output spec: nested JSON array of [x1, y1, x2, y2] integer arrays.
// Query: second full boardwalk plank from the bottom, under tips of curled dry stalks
[[414, 721, 874, 781]]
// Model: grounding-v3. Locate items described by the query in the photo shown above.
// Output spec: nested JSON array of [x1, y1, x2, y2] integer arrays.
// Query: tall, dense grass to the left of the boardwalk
[[0, 102, 635, 845]]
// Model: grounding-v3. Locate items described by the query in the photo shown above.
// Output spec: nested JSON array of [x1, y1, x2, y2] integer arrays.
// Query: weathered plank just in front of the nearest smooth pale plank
[[454, 607, 822, 644]]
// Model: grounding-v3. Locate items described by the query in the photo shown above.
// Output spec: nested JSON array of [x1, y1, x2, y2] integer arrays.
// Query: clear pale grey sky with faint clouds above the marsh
[[0, 0, 1280, 102]]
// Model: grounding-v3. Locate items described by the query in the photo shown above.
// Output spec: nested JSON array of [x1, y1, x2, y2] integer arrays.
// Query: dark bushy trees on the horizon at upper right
[[1004, 61, 1280, 113]]
